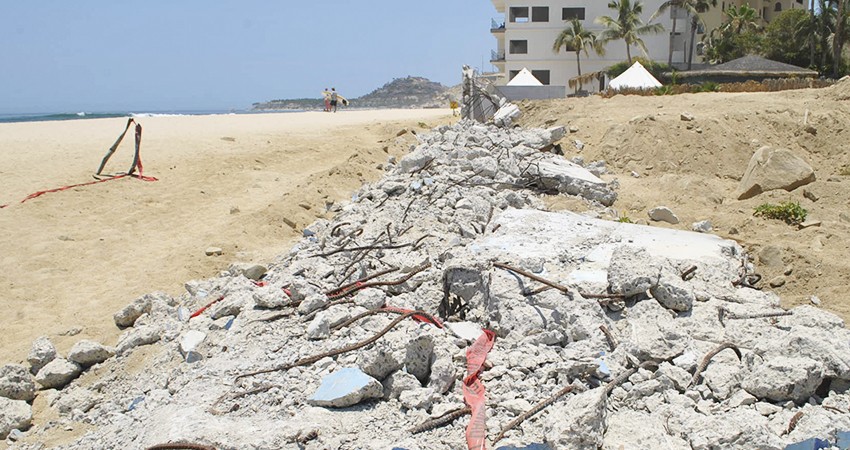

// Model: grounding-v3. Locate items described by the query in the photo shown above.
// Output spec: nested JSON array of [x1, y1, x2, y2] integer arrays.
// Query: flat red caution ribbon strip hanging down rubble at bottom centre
[[463, 330, 496, 450]]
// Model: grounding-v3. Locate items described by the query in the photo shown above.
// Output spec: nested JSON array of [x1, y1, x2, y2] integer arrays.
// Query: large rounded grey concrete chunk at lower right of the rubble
[[741, 356, 823, 403]]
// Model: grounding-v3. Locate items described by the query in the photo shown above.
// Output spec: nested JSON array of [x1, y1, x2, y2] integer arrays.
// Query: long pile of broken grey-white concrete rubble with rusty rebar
[[6, 117, 850, 450]]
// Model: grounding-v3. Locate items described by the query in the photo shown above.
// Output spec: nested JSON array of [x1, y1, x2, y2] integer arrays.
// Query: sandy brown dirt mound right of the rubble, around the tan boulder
[[521, 87, 850, 320]]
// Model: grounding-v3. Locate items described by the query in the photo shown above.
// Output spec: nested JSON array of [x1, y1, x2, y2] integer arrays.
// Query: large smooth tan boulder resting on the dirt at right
[[738, 146, 815, 200]]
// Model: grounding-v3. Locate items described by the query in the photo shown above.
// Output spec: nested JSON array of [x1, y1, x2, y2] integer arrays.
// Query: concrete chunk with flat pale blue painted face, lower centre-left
[[307, 367, 384, 408]]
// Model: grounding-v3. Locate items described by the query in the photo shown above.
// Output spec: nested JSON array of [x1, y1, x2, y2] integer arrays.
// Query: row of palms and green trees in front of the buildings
[[552, 0, 850, 90]]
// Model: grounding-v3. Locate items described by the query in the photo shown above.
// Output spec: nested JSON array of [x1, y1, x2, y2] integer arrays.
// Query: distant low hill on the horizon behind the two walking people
[[252, 76, 458, 111]]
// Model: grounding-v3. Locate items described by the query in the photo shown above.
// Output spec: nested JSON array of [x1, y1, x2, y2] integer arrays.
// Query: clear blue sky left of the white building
[[0, 0, 498, 114]]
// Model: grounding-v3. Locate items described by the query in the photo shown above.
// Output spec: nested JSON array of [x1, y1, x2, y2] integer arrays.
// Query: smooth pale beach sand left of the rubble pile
[[0, 110, 452, 363]]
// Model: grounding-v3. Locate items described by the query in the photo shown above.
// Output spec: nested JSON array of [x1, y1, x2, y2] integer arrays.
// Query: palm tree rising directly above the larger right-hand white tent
[[596, 0, 664, 65]]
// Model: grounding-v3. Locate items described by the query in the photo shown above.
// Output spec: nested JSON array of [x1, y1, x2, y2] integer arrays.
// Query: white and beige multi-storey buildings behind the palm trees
[[490, 0, 808, 91]]
